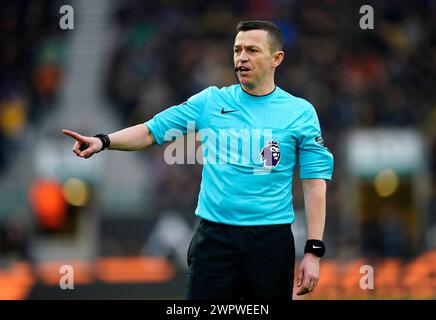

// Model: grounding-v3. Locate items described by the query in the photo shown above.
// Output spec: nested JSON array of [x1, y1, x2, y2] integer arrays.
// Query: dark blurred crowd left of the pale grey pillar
[[0, 0, 65, 173]]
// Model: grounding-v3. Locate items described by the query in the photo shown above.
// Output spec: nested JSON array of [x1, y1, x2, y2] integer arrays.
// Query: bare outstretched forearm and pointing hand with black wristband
[[62, 124, 155, 158]]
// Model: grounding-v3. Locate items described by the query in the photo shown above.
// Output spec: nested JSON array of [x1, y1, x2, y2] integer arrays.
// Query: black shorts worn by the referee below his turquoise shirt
[[186, 219, 295, 300]]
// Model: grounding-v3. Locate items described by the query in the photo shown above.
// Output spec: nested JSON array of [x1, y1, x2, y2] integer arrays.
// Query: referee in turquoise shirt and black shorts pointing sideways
[[64, 21, 333, 300]]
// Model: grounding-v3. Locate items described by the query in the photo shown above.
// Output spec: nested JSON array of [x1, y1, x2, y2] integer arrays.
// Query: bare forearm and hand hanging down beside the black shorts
[[297, 179, 327, 295]]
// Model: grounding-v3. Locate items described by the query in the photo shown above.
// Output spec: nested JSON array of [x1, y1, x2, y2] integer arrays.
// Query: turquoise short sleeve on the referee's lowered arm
[[298, 105, 333, 180]]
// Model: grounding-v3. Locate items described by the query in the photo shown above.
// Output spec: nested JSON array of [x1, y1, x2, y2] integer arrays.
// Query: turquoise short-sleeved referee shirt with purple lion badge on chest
[[145, 84, 333, 226]]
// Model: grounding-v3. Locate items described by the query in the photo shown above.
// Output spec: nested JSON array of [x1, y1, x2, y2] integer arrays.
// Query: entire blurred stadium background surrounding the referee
[[0, 0, 436, 299]]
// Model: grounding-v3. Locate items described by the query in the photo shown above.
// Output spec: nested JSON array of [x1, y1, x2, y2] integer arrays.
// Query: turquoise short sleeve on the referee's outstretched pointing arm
[[144, 88, 210, 145]]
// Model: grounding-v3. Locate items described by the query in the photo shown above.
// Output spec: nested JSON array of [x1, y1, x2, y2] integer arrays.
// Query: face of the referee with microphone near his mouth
[[233, 30, 275, 88]]
